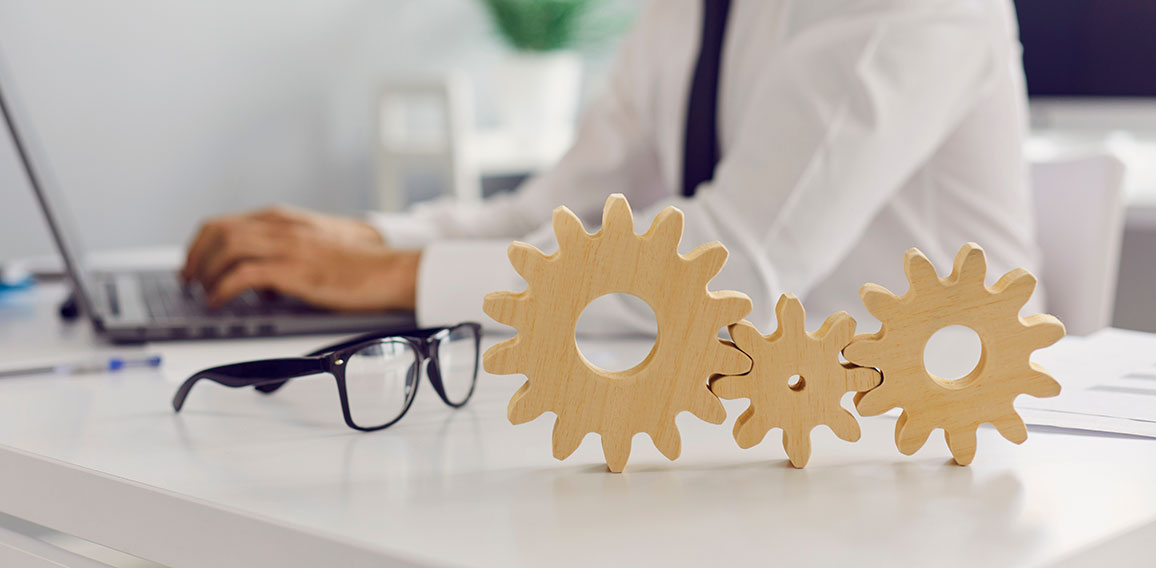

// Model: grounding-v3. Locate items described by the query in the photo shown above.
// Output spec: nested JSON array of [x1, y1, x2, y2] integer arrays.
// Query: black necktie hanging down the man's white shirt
[[682, 0, 731, 197]]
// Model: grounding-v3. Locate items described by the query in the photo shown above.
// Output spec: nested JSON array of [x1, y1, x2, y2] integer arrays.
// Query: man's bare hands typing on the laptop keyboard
[[180, 207, 421, 310]]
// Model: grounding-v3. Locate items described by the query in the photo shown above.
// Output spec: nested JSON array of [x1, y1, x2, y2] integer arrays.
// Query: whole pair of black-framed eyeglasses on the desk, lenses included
[[172, 322, 482, 431]]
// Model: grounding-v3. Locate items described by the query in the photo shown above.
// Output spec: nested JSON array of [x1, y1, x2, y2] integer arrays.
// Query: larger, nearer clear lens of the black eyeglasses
[[346, 340, 420, 428]]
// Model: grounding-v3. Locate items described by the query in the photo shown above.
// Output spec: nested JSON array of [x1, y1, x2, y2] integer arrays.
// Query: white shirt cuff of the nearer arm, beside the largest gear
[[416, 241, 524, 329]]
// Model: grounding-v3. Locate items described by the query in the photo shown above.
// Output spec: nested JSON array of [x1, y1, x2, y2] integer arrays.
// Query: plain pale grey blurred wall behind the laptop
[[0, 0, 635, 259]]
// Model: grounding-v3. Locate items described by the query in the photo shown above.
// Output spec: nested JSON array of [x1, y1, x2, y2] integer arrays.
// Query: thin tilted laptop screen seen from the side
[[0, 50, 96, 318]]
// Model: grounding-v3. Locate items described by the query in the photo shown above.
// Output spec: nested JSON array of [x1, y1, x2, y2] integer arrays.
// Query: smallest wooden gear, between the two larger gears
[[711, 294, 881, 467]]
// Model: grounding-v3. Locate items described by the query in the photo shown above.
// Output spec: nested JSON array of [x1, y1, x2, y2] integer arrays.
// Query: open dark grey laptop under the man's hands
[[0, 52, 415, 342]]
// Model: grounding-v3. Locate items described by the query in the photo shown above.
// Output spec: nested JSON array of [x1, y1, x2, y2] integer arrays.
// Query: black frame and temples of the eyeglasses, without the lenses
[[172, 322, 482, 431]]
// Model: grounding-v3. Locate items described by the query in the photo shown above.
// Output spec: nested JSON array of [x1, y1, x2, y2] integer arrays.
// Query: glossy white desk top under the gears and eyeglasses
[[0, 287, 1156, 567]]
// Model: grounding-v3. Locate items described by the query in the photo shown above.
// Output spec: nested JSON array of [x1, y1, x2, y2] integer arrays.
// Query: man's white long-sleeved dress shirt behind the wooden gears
[[372, 0, 1043, 333]]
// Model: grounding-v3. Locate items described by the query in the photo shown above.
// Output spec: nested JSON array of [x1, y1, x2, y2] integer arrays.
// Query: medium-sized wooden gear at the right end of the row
[[843, 243, 1064, 465]]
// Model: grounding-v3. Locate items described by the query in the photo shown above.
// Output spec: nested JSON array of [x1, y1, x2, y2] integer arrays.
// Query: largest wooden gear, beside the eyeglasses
[[483, 194, 751, 472]]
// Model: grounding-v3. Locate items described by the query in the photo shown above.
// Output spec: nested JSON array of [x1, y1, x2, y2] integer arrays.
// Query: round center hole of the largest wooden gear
[[575, 293, 658, 372]]
